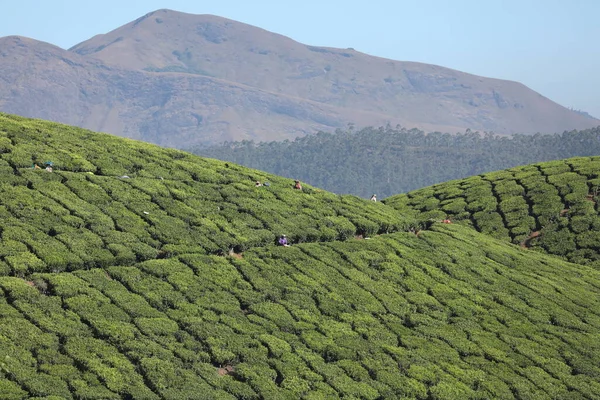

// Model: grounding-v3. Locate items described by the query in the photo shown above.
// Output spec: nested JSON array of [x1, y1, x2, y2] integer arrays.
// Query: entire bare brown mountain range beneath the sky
[[0, 10, 600, 148]]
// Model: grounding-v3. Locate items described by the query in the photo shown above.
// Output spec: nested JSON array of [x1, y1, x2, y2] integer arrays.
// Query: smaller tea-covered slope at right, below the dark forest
[[385, 157, 600, 266]]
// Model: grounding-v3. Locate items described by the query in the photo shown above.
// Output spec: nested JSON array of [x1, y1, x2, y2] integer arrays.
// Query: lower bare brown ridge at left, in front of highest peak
[[0, 37, 390, 147]]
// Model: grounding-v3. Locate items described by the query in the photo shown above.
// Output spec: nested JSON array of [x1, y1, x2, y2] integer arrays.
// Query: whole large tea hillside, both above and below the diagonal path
[[0, 114, 600, 400]]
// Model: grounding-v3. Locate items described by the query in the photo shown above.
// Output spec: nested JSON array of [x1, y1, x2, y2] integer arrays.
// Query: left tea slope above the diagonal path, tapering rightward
[[0, 115, 413, 276]]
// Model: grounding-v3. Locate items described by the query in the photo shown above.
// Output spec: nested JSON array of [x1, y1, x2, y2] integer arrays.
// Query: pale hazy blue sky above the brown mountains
[[0, 0, 600, 118]]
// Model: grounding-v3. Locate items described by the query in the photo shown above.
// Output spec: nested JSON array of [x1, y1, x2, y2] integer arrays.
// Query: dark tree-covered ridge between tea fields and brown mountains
[[195, 126, 600, 199]]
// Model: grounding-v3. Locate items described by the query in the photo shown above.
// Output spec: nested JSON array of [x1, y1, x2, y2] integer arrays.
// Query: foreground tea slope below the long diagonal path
[[0, 225, 600, 399]]
